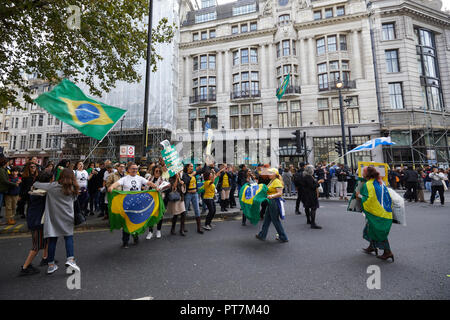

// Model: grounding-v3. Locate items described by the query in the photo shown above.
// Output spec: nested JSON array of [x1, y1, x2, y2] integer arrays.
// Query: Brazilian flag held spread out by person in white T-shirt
[[108, 190, 166, 234]]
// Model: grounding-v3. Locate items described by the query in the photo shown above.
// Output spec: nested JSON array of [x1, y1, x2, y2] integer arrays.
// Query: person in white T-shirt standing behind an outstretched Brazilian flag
[[108, 162, 158, 249]]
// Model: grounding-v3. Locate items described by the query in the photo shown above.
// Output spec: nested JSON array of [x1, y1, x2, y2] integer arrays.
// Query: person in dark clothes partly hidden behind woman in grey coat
[[19, 171, 52, 275]]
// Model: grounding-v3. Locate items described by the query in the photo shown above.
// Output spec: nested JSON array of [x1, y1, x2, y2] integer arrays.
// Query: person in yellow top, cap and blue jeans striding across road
[[256, 168, 289, 242]]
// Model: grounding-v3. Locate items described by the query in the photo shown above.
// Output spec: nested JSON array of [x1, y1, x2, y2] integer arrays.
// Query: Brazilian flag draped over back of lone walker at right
[[360, 180, 392, 241]]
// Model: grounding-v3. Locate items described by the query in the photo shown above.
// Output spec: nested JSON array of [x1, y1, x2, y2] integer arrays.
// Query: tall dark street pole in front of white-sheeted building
[[142, 0, 153, 157]]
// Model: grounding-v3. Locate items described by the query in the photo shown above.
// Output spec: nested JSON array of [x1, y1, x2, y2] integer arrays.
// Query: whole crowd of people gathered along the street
[[0, 157, 448, 275]]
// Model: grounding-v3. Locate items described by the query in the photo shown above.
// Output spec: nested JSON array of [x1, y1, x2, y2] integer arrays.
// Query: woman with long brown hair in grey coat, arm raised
[[33, 168, 79, 274]]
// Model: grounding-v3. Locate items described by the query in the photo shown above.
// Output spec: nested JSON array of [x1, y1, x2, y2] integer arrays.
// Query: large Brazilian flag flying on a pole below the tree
[[34, 79, 127, 140]]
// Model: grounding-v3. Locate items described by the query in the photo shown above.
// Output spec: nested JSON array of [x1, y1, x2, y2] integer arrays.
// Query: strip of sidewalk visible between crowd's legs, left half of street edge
[[0, 206, 242, 237]]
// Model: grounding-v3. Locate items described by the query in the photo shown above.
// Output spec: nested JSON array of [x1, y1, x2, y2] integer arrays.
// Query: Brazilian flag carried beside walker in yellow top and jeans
[[239, 183, 267, 225]]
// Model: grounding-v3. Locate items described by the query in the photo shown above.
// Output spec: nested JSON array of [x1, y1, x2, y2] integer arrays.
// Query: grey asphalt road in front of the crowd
[[0, 201, 450, 300]]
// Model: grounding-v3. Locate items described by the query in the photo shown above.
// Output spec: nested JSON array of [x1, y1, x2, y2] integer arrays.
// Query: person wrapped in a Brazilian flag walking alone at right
[[356, 167, 394, 262]]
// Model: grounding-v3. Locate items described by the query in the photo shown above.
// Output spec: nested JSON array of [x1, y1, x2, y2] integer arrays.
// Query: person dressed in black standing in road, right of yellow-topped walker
[[300, 165, 324, 229]]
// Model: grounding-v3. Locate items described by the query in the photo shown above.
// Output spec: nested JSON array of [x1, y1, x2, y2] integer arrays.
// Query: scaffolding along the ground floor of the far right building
[[381, 110, 450, 167]]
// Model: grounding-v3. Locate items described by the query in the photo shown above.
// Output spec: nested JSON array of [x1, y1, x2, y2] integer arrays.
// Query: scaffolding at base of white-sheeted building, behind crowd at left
[[51, 128, 171, 162]]
